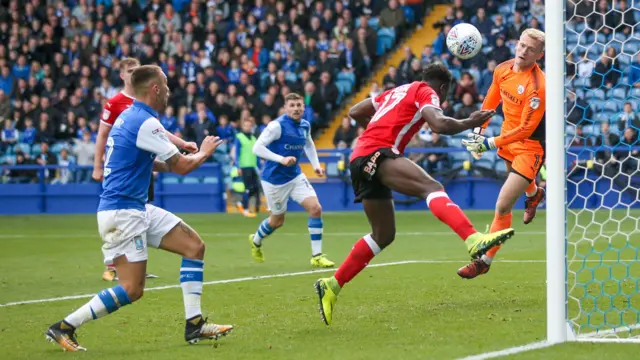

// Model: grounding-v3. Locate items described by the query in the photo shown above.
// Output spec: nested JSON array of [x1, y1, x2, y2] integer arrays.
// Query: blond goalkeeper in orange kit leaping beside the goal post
[[458, 29, 548, 279]]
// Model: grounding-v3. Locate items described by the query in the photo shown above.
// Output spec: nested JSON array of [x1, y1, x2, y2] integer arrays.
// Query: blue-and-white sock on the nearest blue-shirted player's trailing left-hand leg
[[64, 285, 131, 329]]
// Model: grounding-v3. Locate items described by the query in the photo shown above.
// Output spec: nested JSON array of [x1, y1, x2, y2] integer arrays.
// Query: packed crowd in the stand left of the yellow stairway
[[0, 0, 425, 182]]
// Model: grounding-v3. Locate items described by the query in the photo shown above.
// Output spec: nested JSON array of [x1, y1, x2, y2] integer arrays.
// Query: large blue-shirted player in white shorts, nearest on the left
[[45, 65, 233, 351]]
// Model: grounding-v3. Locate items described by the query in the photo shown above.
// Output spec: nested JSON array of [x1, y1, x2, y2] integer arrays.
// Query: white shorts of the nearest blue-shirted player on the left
[[98, 204, 182, 265]]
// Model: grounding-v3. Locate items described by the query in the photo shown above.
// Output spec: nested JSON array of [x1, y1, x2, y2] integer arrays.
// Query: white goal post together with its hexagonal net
[[544, 0, 640, 344]]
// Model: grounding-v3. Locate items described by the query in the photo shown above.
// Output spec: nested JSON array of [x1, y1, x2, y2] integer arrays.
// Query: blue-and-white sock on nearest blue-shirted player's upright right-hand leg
[[180, 258, 204, 320]]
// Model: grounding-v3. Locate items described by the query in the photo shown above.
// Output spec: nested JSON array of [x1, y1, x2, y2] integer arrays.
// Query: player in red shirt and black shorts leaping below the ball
[[315, 64, 514, 325]]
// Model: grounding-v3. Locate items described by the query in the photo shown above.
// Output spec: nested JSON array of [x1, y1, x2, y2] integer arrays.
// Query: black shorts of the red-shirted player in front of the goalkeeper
[[349, 148, 402, 203]]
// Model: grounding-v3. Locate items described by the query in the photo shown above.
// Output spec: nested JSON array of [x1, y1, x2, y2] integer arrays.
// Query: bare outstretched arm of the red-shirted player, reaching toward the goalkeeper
[[420, 106, 495, 135]]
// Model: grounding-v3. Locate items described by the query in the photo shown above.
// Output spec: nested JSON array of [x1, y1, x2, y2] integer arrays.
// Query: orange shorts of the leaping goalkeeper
[[498, 140, 545, 182]]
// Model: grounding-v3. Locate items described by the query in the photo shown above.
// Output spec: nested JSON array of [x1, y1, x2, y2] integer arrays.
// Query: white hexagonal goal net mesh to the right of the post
[[564, 0, 640, 339]]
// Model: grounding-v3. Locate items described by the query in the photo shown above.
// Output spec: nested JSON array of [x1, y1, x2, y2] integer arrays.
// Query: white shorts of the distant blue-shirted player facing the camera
[[262, 174, 316, 215]]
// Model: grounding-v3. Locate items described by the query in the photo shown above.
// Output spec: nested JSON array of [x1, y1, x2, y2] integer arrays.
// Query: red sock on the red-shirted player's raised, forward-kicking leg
[[427, 191, 477, 240]]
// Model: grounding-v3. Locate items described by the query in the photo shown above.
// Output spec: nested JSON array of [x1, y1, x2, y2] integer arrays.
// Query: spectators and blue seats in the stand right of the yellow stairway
[[334, 0, 640, 176]]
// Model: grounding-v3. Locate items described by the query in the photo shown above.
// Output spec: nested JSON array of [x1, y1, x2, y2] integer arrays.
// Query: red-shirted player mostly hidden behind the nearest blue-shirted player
[[92, 58, 198, 281]]
